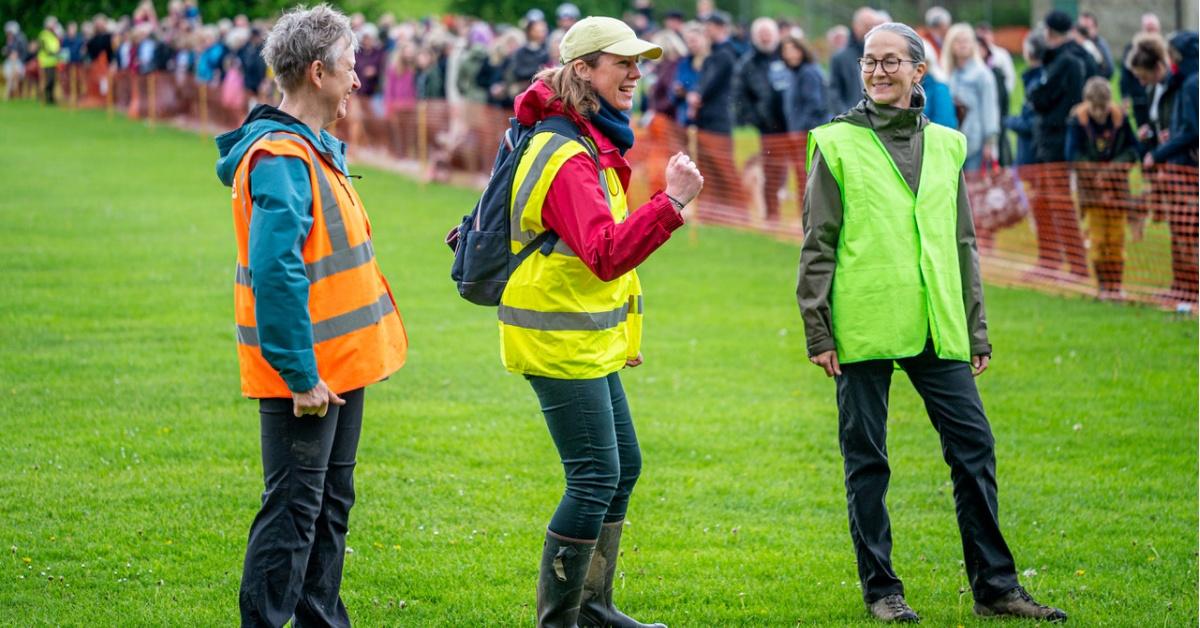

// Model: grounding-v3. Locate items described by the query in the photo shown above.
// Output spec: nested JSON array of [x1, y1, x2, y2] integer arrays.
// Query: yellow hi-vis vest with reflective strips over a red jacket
[[498, 132, 642, 379]]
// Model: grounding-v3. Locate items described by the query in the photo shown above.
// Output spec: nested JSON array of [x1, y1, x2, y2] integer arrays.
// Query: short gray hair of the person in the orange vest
[[263, 4, 359, 91]]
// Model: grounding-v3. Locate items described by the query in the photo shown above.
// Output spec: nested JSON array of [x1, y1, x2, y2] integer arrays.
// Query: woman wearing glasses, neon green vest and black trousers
[[797, 23, 1067, 622]]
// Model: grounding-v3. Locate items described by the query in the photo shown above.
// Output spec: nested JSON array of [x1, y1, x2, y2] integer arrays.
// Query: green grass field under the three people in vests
[[0, 103, 1198, 628]]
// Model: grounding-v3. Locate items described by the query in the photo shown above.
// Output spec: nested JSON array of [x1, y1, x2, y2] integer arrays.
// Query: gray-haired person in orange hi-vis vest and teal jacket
[[217, 5, 408, 627]]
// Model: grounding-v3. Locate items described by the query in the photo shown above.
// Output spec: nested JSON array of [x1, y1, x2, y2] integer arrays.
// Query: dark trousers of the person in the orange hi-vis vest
[[238, 388, 362, 627]]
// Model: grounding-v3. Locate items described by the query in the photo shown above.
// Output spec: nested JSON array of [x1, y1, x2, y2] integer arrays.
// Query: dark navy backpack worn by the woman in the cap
[[445, 115, 600, 305]]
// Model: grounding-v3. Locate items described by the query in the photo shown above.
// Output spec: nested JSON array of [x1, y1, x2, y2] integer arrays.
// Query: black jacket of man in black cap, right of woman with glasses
[[1025, 42, 1087, 163]]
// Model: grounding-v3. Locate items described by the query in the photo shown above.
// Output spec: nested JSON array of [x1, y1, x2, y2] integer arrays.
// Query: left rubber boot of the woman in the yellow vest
[[538, 531, 595, 628]]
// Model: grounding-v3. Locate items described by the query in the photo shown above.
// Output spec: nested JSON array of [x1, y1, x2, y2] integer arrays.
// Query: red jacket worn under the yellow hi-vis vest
[[515, 80, 683, 281]]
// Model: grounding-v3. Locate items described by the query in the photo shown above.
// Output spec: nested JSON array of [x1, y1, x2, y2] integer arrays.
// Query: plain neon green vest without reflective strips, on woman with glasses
[[808, 122, 971, 364]]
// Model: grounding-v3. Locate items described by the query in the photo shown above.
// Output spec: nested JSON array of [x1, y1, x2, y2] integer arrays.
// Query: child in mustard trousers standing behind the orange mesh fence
[[1067, 77, 1140, 300]]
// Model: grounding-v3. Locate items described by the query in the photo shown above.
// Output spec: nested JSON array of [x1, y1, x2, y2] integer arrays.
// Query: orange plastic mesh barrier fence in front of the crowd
[[91, 71, 1198, 311]]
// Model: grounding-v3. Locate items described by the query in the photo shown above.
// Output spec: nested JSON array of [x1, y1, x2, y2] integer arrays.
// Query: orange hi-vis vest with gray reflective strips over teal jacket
[[233, 132, 408, 399]]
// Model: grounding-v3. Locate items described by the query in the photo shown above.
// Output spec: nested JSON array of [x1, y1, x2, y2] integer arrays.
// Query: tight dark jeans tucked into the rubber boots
[[527, 373, 642, 540]]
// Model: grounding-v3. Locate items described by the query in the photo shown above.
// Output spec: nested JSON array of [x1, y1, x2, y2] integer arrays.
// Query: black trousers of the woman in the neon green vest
[[838, 343, 1018, 604]]
